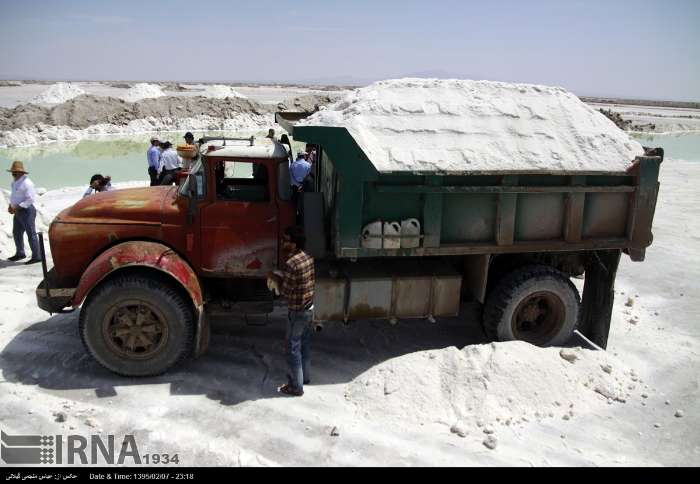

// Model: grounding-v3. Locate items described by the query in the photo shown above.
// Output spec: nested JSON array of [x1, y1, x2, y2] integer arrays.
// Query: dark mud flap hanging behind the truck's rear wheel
[[579, 250, 621, 349]]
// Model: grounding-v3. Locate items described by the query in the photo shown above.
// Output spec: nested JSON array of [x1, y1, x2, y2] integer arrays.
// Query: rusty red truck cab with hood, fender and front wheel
[[37, 138, 296, 376]]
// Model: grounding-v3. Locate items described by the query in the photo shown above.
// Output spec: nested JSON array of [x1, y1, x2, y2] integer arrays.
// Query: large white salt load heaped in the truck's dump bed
[[299, 79, 644, 173]]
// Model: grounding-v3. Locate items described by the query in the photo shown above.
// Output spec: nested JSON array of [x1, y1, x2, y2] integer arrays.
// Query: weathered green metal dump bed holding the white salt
[[277, 113, 663, 260]]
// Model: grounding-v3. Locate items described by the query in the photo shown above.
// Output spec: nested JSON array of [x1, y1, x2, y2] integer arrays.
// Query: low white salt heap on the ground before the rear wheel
[[346, 341, 641, 429]]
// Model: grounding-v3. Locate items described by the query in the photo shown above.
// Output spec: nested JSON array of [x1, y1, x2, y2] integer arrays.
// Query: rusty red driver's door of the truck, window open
[[200, 161, 279, 277]]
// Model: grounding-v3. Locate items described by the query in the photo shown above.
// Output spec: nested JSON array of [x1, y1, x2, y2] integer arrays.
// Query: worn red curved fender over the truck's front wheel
[[71, 241, 209, 356]]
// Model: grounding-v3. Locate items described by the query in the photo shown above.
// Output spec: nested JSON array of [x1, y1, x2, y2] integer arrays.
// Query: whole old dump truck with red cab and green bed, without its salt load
[[36, 125, 663, 376]]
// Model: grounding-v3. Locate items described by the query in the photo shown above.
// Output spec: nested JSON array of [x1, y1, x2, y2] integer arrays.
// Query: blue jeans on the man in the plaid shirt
[[286, 311, 313, 390]]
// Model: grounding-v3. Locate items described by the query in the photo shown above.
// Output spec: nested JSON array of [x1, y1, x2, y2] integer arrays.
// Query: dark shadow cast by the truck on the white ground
[[0, 306, 494, 405]]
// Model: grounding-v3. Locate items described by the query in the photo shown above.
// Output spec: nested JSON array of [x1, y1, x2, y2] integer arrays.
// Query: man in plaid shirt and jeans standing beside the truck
[[269, 227, 316, 397]]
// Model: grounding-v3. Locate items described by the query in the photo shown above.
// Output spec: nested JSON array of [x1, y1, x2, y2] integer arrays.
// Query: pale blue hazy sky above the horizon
[[0, 0, 700, 101]]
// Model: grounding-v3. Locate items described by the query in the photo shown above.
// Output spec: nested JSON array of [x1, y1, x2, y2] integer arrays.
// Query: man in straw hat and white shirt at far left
[[7, 161, 41, 264]]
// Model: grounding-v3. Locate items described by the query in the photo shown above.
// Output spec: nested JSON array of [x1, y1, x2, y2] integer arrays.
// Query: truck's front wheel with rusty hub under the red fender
[[80, 275, 195, 376]]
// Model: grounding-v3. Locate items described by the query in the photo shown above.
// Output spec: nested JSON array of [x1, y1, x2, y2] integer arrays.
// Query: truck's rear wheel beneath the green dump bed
[[483, 265, 581, 346]]
